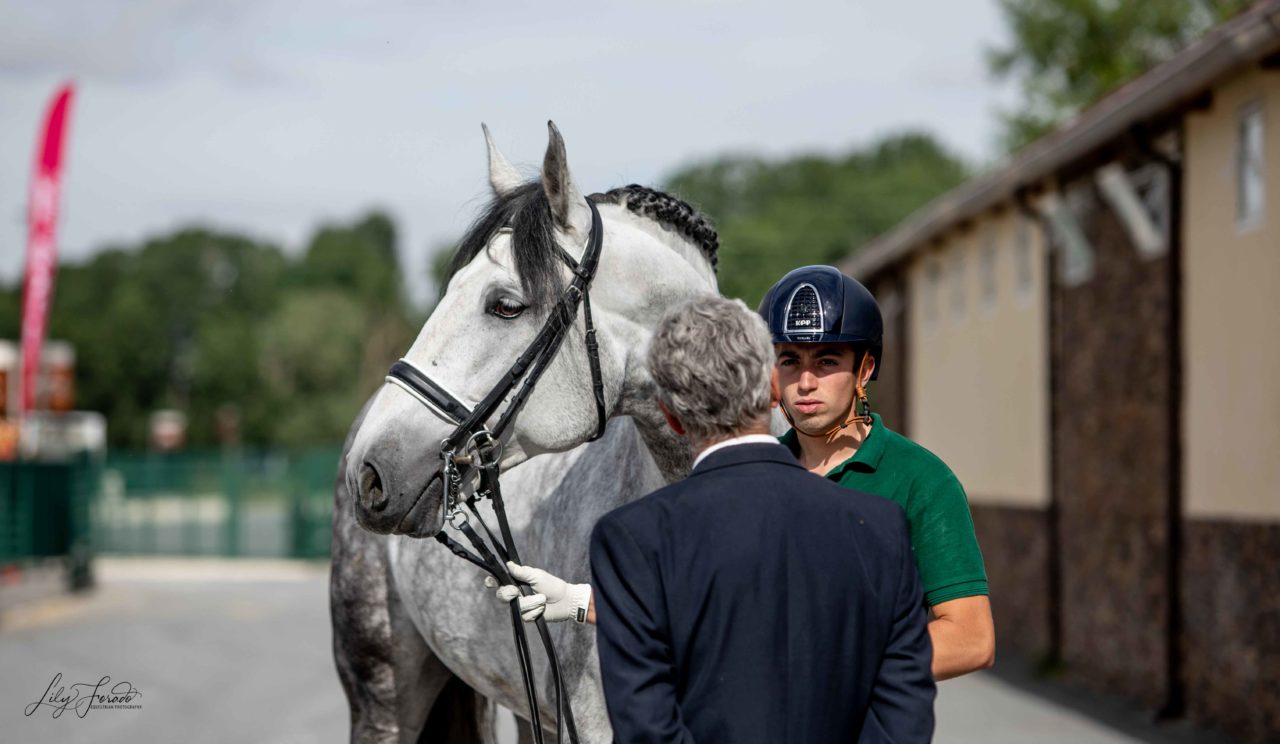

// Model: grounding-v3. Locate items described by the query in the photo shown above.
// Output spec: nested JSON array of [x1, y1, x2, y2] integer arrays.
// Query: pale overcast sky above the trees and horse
[[0, 0, 1009, 304]]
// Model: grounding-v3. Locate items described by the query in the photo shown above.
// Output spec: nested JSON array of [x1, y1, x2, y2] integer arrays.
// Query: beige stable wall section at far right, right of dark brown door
[[1183, 66, 1280, 520]]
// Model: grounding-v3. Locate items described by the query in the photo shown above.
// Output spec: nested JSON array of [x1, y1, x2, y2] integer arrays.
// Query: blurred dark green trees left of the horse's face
[[0, 213, 413, 447]]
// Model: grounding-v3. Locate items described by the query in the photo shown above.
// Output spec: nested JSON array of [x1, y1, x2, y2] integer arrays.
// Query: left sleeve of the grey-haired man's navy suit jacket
[[591, 516, 694, 744]]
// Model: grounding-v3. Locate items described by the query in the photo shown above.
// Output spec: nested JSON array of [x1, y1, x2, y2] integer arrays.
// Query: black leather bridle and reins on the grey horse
[[387, 198, 608, 744]]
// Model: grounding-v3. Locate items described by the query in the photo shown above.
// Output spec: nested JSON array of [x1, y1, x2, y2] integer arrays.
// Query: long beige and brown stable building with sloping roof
[[841, 0, 1280, 741]]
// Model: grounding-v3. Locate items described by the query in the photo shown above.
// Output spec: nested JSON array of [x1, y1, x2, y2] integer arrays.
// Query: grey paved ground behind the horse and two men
[[0, 560, 1208, 744]]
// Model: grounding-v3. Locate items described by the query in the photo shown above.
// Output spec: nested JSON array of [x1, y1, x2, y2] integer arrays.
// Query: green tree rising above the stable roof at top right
[[987, 0, 1251, 151]]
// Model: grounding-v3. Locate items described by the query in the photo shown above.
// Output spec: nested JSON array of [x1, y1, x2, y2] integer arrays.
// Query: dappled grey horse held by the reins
[[330, 124, 718, 743]]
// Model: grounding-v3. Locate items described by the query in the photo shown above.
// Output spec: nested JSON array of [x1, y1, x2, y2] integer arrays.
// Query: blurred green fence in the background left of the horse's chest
[[92, 446, 340, 558]]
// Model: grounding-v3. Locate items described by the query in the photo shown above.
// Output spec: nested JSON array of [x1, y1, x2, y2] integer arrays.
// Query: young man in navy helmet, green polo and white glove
[[488, 266, 996, 681]]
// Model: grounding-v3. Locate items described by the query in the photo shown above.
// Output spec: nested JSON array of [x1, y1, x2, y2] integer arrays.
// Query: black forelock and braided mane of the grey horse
[[442, 181, 719, 306]]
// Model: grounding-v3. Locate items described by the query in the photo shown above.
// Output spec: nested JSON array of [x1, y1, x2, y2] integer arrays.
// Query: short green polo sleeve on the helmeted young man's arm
[[908, 470, 988, 607]]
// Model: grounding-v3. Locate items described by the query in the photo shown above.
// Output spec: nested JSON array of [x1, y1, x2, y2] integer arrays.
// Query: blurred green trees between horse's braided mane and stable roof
[[664, 133, 966, 306]]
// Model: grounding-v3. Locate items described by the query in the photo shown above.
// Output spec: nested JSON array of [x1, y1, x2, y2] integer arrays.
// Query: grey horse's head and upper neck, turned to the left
[[346, 124, 716, 537]]
